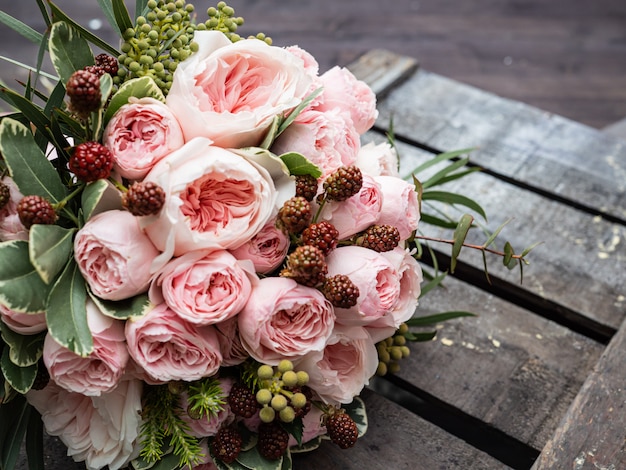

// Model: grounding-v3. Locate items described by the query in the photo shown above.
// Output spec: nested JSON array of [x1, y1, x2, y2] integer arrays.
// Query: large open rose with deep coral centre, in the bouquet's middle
[[141, 138, 277, 261]]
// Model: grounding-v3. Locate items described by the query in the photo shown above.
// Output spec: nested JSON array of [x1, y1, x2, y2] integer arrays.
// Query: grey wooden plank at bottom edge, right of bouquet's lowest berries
[[294, 390, 509, 470]]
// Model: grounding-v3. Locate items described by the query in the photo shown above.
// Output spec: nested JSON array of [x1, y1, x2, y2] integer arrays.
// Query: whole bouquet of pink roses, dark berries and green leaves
[[0, 0, 526, 470]]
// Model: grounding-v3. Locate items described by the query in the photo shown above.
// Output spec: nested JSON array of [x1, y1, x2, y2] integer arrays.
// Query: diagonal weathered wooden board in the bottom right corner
[[533, 316, 626, 470]]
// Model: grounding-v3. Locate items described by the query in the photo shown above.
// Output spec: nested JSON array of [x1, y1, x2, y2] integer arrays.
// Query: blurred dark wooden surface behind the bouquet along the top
[[0, 0, 626, 128]]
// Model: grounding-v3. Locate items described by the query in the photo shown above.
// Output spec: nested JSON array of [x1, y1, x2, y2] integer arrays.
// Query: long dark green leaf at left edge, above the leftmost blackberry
[[0, 118, 66, 202]]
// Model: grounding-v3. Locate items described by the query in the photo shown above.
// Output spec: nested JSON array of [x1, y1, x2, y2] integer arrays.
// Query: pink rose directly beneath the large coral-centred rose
[[150, 250, 256, 325]]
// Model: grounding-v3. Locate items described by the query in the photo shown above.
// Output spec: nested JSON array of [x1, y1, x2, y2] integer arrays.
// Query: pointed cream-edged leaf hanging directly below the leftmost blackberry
[[28, 225, 76, 284]]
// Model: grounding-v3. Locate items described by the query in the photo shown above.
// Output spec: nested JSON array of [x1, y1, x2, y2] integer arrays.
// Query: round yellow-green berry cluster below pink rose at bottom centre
[[256, 359, 309, 423]]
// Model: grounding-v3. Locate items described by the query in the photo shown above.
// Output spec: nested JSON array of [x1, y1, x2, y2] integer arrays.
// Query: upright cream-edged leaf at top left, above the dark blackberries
[[49, 21, 94, 84]]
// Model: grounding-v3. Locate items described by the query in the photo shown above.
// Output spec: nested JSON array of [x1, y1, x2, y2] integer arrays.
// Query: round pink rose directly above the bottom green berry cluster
[[238, 277, 335, 365]]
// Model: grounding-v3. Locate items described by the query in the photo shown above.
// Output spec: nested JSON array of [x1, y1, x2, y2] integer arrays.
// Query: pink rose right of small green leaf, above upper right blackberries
[[271, 108, 361, 177]]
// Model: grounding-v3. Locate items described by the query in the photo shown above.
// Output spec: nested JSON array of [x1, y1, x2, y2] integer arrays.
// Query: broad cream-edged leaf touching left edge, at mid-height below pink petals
[[0, 240, 49, 313]]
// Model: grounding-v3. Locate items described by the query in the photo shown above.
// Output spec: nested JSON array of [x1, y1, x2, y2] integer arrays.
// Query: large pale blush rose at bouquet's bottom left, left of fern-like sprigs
[[26, 380, 142, 470]]
